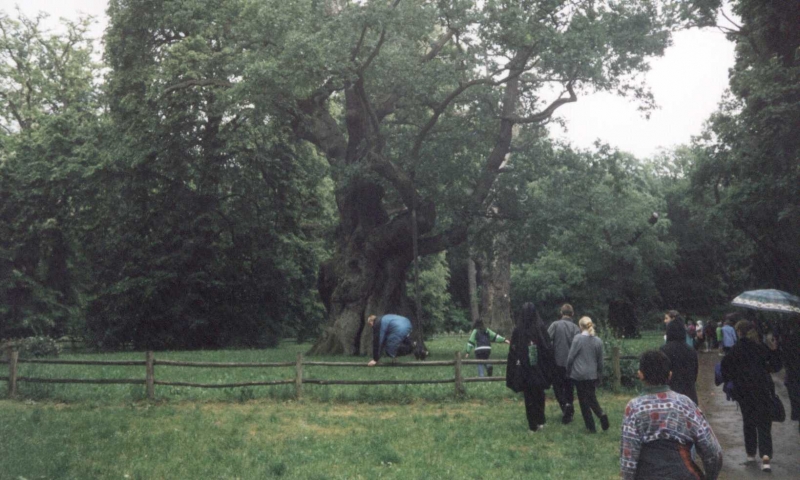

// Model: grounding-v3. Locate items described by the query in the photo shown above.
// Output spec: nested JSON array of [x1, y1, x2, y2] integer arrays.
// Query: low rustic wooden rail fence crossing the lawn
[[0, 347, 638, 400]]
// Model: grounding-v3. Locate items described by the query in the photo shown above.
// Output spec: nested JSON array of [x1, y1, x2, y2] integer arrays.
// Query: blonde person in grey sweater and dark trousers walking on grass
[[567, 317, 609, 433]]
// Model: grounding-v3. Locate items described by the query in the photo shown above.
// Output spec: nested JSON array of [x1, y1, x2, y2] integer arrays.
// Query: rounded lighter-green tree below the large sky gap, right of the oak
[[503, 137, 675, 318]]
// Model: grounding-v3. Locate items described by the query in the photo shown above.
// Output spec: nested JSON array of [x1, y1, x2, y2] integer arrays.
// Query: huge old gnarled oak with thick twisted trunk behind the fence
[[220, 0, 712, 354]]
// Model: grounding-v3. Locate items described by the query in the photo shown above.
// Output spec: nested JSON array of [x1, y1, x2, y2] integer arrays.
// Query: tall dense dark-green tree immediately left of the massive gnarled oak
[[87, 0, 331, 348]]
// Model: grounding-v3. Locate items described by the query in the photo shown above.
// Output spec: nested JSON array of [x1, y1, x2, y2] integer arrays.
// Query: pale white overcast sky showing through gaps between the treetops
[[0, 0, 734, 158]]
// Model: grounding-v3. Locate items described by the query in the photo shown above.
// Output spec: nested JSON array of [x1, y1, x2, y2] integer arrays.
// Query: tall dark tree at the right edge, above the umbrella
[[691, 0, 800, 295]]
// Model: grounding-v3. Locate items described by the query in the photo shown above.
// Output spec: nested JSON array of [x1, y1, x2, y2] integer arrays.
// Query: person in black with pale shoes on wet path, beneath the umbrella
[[720, 320, 781, 472]]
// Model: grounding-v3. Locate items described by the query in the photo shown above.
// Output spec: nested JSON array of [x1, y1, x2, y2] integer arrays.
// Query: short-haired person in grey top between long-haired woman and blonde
[[547, 303, 581, 424]]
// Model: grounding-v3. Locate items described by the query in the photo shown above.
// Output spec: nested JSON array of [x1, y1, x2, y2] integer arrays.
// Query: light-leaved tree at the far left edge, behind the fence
[[0, 11, 101, 338]]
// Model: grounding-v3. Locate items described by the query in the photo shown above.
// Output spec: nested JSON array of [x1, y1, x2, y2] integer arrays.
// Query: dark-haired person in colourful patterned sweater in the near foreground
[[619, 350, 722, 480]]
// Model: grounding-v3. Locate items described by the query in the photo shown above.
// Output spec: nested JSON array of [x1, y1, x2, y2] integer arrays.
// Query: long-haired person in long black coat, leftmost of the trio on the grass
[[506, 302, 555, 432]]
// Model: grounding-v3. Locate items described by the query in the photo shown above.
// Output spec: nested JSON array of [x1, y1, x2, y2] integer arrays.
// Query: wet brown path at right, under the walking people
[[697, 352, 800, 480]]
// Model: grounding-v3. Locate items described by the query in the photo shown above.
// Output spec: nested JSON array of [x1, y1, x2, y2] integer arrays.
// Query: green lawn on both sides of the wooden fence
[[0, 337, 657, 480]]
